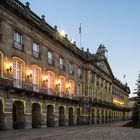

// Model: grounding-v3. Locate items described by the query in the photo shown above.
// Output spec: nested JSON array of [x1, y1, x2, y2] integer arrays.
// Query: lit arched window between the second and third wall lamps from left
[[32, 65, 41, 92]]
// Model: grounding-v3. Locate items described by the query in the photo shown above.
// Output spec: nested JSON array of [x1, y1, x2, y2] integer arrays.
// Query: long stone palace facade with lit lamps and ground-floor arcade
[[0, 0, 130, 129]]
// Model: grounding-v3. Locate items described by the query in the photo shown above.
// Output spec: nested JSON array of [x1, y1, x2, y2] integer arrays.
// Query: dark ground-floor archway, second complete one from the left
[[32, 103, 41, 128]]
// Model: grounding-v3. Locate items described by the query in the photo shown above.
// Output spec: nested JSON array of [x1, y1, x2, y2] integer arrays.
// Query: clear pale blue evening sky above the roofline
[[21, 0, 140, 96]]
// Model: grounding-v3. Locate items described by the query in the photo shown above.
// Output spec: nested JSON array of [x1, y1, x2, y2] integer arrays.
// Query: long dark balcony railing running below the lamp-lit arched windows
[[0, 77, 80, 101]]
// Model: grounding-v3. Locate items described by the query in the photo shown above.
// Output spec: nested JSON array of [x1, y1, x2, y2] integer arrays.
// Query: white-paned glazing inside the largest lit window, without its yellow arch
[[14, 60, 22, 88]]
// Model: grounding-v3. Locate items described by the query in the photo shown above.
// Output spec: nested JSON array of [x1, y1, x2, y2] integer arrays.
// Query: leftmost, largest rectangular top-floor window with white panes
[[14, 31, 23, 50]]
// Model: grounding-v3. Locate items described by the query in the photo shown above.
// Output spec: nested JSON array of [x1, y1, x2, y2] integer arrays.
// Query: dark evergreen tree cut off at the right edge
[[132, 73, 140, 127]]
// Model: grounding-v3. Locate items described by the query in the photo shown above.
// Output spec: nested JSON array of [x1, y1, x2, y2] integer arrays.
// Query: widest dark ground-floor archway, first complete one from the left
[[13, 101, 25, 129]]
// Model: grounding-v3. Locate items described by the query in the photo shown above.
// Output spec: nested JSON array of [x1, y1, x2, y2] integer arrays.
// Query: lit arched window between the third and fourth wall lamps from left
[[47, 71, 55, 94]]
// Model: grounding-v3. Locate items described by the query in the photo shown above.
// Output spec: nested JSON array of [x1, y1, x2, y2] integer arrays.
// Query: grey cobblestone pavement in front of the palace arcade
[[0, 122, 140, 140]]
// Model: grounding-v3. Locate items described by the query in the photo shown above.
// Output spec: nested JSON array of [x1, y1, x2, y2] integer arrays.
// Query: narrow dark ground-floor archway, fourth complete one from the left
[[59, 106, 65, 126]]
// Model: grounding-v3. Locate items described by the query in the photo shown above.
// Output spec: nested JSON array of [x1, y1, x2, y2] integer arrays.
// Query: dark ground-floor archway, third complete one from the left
[[47, 105, 55, 127]]
